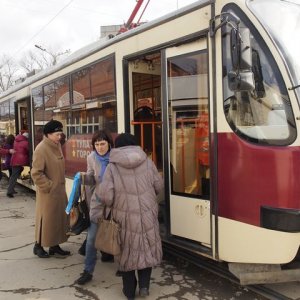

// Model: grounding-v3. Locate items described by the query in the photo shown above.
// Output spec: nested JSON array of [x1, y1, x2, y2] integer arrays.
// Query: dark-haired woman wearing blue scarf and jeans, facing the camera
[[75, 130, 114, 285]]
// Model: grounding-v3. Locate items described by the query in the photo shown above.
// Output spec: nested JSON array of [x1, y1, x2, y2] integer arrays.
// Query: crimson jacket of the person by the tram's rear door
[[10, 134, 29, 167]]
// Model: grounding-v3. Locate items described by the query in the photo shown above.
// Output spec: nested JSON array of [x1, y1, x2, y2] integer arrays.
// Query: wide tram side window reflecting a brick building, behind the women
[[32, 57, 117, 177]]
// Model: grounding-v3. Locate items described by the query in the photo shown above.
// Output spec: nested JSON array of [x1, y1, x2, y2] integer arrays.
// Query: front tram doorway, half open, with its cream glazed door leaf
[[128, 39, 211, 251]]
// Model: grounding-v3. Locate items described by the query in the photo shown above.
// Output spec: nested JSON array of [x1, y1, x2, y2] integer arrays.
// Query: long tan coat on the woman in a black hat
[[31, 137, 68, 247]]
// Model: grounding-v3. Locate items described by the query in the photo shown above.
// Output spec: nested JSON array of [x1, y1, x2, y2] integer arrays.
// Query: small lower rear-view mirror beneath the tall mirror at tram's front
[[228, 71, 255, 91]]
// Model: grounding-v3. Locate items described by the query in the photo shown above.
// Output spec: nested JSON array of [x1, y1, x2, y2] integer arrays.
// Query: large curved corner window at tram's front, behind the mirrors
[[222, 5, 296, 145]]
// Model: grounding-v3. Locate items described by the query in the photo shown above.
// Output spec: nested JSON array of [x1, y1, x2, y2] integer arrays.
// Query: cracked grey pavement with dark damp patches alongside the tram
[[0, 178, 264, 300]]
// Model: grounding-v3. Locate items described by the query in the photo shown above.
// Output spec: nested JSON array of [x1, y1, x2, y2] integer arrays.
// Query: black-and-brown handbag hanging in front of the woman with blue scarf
[[67, 174, 90, 235]]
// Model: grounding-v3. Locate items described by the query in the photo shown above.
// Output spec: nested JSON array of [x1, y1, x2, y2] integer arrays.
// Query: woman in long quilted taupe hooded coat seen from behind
[[96, 133, 163, 299]]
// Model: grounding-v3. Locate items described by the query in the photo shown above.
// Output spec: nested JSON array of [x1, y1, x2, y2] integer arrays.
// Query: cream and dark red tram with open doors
[[0, 0, 300, 284]]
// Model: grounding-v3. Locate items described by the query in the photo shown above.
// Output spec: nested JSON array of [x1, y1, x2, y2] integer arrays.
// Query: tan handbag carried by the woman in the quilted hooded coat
[[95, 207, 121, 255]]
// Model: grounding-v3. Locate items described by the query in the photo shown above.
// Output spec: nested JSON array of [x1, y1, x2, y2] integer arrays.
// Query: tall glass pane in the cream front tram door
[[168, 51, 210, 199]]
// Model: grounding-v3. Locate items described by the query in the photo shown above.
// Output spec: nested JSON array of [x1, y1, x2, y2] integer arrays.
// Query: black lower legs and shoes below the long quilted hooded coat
[[122, 268, 152, 298]]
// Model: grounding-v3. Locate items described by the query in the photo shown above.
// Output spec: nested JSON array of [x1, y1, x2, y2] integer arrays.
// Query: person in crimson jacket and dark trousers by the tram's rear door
[[7, 132, 29, 198]]
